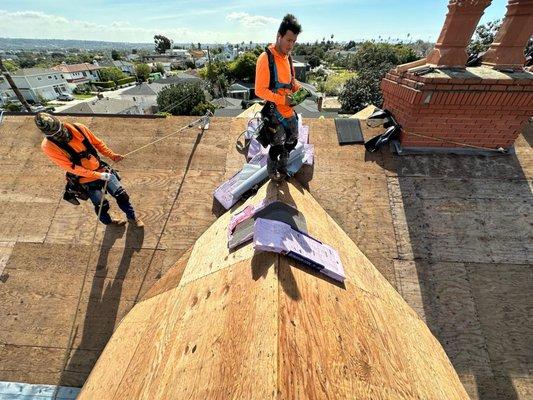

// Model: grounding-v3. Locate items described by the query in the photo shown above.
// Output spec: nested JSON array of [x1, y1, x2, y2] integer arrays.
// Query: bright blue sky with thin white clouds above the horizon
[[0, 0, 507, 43]]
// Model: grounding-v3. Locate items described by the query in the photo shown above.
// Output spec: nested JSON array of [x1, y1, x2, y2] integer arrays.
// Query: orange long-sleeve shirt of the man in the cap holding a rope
[[41, 123, 116, 183]]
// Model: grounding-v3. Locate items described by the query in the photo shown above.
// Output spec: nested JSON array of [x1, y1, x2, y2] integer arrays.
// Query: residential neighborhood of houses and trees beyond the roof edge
[[0, 37, 364, 117]]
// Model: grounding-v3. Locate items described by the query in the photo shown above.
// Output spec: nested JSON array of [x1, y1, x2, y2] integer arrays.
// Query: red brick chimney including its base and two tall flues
[[381, 0, 533, 151]]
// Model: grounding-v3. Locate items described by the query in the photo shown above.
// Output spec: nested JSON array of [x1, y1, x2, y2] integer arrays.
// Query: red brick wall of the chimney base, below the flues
[[381, 67, 533, 149]]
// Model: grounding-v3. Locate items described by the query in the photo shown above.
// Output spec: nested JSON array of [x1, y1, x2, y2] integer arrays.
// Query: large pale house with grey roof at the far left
[[5, 68, 72, 102]]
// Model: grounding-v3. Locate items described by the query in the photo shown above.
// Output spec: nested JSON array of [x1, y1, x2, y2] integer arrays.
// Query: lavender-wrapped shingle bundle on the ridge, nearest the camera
[[254, 218, 345, 282]]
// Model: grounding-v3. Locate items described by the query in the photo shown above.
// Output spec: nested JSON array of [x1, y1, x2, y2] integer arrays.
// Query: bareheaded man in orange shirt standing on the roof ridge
[[255, 14, 309, 180]]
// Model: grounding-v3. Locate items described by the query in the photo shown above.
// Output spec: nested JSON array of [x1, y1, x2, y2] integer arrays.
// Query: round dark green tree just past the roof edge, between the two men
[[157, 83, 206, 115]]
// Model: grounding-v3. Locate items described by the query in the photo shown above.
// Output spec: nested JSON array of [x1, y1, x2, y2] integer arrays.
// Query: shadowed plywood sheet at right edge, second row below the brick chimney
[[389, 177, 533, 264]]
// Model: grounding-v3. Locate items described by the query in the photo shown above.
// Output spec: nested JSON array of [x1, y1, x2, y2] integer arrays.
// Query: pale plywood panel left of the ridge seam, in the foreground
[[79, 263, 277, 399]]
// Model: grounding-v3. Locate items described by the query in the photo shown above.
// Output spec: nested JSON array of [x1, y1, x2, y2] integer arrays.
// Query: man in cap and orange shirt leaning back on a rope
[[35, 112, 144, 228]]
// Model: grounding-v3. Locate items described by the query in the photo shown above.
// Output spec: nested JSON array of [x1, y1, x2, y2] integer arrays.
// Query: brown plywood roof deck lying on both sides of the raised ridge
[[0, 117, 533, 399]]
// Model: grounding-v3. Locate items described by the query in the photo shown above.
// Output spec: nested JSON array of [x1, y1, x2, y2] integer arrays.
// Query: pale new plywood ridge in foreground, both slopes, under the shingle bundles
[[79, 181, 468, 400]]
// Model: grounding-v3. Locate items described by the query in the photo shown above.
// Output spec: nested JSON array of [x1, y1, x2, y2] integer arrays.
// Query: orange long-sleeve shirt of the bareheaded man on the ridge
[[255, 44, 300, 118]]
